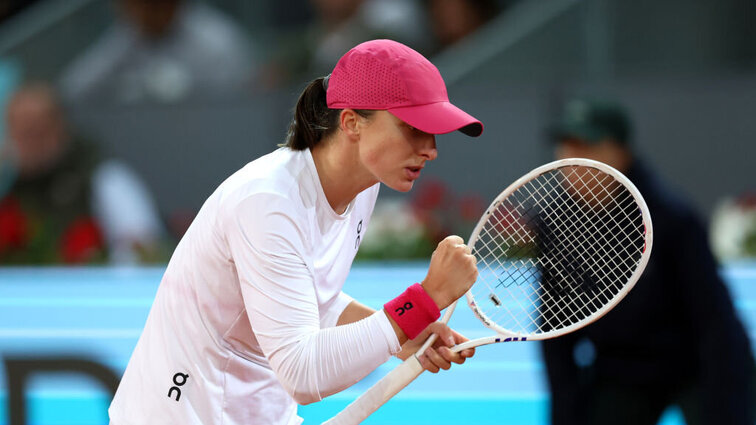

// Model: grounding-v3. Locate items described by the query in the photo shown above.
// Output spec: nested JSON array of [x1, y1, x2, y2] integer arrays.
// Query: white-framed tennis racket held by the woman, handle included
[[324, 158, 653, 425]]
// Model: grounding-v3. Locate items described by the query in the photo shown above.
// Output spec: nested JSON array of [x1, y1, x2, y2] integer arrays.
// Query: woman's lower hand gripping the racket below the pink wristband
[[396, 322, 475, 373]]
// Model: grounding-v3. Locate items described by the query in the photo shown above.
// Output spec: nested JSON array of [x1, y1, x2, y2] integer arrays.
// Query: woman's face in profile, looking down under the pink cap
[[359, 111, 438, 192]]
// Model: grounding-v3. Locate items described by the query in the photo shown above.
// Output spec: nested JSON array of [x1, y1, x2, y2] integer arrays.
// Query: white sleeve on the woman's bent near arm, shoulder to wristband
[[224, 195, 401, 404]]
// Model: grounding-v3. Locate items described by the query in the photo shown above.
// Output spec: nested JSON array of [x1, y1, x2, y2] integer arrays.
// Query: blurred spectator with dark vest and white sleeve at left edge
[[0, 83, 164, 264]]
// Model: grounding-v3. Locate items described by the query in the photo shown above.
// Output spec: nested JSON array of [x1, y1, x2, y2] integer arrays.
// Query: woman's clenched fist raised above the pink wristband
[[422, 236, 478, 310]]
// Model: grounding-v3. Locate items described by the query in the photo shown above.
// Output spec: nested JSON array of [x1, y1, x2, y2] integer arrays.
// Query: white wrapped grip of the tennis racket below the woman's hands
[[323, 356, 423, 425]]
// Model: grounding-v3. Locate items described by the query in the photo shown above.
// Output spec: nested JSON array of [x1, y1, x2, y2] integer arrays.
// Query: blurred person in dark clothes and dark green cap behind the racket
[[542, 100, 754, 425]]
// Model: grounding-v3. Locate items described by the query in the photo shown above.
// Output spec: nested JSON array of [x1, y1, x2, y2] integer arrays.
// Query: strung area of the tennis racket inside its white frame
[[472, 166, 645, 334]]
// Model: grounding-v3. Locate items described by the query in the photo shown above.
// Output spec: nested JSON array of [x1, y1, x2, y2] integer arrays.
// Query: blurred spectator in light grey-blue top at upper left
[[61, 0, 254, 103]]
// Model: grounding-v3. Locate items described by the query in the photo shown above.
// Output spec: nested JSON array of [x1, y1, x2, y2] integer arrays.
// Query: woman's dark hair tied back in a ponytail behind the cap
[[283, 76, 373, 151]]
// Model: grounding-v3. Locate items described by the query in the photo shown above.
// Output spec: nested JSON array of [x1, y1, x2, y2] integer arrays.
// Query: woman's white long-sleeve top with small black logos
[[109, 148, 400, 425]]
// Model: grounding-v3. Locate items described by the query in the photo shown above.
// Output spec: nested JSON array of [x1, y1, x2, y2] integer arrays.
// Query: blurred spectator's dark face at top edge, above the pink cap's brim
[[425, 0, 499, 50]]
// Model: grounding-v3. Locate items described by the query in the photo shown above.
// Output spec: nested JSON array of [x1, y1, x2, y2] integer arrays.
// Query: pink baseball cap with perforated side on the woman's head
[[326, 40, 483, 137]]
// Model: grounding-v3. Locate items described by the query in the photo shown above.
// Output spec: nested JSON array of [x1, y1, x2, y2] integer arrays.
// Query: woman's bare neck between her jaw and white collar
[[312, 137, 378, 214]]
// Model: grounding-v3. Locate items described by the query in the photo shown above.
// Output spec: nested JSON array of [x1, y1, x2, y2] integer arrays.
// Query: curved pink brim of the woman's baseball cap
[[388, 102, 483, 137]]
